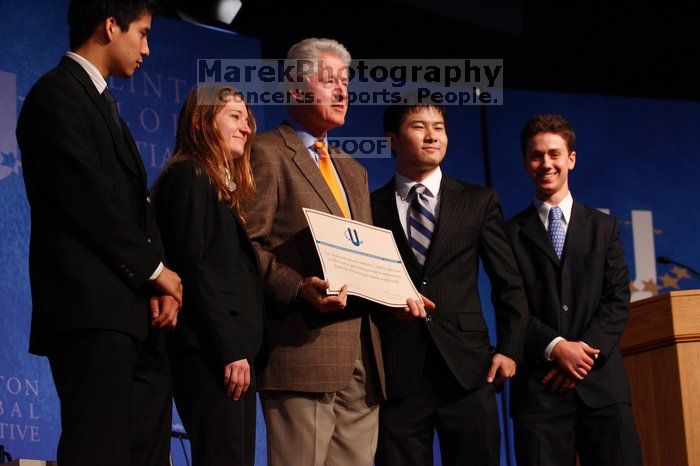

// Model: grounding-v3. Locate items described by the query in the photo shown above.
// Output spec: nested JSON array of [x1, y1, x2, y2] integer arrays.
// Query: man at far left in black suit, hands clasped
[[17, 0, 182, 465]]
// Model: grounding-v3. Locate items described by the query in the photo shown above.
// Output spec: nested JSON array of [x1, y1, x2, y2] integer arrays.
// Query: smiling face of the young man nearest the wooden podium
[[525, 132, 576, 205]]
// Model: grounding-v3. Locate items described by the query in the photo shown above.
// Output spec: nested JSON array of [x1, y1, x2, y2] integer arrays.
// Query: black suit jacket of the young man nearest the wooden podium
[[506, 202, 630, 412]]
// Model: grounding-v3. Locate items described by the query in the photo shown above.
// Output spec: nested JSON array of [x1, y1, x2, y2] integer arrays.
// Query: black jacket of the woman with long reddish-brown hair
[[153, 161, 264, 369]]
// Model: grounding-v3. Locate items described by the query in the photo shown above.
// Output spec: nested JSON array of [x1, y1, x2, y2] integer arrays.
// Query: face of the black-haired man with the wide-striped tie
[[386, 107, 447, 181]]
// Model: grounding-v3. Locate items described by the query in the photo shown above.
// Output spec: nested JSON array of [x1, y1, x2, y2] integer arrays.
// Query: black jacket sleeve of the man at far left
[[17, 76, 162, 290]]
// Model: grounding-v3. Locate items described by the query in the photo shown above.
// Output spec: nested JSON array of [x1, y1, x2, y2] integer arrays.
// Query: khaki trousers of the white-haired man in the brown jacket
[[260, 338, 379, 466]]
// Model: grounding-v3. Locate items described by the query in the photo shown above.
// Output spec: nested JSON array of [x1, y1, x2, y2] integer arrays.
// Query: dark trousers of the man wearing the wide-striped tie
[[375, 344, 500, 466]]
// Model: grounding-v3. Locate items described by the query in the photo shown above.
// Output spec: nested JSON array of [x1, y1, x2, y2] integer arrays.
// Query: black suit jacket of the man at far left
[[17, 57, 162, 354]]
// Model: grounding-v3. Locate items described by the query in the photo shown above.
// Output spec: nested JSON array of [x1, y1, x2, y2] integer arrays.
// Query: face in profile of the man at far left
[[107, 13, 151, 78]]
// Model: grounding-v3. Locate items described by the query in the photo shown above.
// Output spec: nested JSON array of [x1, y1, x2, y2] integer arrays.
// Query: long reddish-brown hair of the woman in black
[[165, 84, 255, 221]]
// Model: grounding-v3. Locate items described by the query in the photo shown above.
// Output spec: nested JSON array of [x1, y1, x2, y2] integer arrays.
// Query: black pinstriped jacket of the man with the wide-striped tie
[[372, 176, 527, 398]]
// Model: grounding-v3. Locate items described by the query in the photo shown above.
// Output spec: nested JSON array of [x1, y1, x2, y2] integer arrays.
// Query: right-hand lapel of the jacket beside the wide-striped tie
[[423, 175, 468, 270]]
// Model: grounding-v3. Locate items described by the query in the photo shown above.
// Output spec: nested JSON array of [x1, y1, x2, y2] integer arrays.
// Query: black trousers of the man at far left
[[48, 330, 172, 466]]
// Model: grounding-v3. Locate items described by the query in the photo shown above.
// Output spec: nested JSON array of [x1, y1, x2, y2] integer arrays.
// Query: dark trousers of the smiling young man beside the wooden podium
[[513, 390, 642, 466]]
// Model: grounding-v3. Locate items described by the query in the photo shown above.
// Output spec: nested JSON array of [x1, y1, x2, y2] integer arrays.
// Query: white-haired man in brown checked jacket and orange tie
[[246, 39, 425, 466]]
